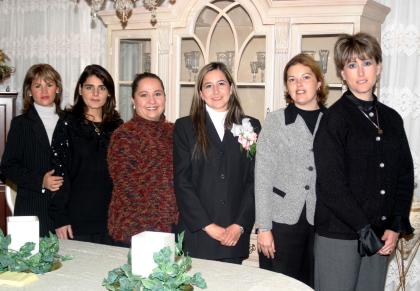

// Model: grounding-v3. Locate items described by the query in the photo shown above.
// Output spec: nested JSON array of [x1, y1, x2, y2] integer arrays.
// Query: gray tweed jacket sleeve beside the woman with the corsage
[[255, 113, 278, 229]]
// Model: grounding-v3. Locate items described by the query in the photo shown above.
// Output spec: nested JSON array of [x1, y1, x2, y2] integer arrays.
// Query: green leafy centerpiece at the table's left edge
[[0, 229, 71, 274]]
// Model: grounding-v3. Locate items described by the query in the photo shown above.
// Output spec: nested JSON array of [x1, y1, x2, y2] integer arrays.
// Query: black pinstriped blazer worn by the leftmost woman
[[1, 106, 65, 236]]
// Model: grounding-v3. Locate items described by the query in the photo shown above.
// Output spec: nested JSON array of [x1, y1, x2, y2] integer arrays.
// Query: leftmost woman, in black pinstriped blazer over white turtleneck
[[1, 64, 66, 236]]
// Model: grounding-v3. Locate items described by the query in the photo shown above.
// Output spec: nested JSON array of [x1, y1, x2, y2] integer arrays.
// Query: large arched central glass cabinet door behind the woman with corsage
[[178, 0, 266, 121]]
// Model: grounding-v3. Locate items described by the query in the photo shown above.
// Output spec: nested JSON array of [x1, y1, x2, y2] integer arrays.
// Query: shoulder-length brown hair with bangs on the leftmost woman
[[22, 64, 63, 113]]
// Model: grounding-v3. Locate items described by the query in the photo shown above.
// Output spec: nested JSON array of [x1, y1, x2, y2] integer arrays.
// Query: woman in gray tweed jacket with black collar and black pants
[[255, 54, 328, 287]]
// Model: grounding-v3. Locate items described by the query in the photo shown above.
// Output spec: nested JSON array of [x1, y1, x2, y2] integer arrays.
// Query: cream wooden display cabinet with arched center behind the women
[[99, 0, 390, 265]]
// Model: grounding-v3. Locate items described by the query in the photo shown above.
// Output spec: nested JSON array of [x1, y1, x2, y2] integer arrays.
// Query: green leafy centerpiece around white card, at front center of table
[[102, 233, 207, 291]]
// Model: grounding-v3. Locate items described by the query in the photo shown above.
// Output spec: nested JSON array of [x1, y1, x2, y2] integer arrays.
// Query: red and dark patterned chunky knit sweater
[[108, 115, 178, 243]]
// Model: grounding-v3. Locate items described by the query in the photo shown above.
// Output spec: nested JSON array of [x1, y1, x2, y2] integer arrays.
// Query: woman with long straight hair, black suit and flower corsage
[[174, 63, 261, 263]]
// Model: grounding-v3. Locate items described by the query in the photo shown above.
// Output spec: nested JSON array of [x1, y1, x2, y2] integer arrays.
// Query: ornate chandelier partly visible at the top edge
[[73, 0, 167, 27]]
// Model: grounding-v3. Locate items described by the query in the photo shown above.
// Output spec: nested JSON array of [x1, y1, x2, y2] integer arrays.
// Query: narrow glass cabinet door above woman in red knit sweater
[[116, 39, 151, 121]]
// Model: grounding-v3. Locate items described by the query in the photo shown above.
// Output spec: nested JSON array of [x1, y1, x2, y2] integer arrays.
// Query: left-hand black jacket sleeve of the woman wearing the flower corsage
[[173, 120, 213, 232]]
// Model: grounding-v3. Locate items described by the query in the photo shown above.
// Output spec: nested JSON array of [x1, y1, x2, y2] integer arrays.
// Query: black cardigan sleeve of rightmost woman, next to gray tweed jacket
[[314, 115, 369, 232]]
